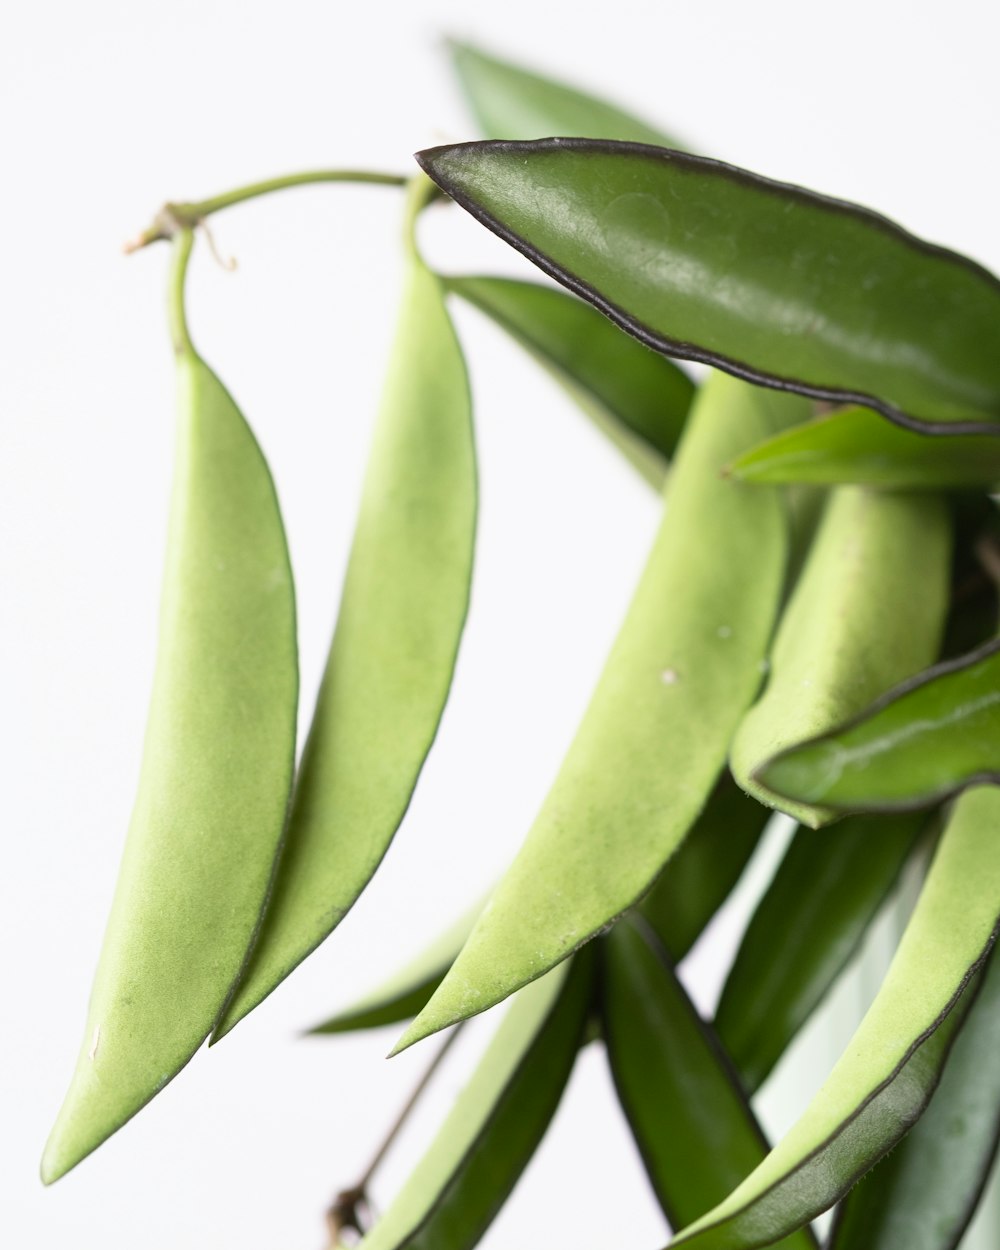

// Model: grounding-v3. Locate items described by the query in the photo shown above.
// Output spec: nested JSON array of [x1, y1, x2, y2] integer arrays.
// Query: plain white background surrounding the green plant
[[0, 0, 1000, 1250]]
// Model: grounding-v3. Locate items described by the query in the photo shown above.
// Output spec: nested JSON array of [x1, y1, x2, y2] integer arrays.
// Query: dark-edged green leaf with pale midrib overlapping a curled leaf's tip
[[758, 643, 1000, 811]]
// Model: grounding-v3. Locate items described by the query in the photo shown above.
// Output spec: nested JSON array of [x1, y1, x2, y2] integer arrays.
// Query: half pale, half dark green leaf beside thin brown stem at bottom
[[363, 953, 593, 1250]]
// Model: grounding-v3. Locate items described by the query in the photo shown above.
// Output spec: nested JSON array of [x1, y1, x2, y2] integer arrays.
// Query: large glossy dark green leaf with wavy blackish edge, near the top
[[418, 139, 1000, 433]]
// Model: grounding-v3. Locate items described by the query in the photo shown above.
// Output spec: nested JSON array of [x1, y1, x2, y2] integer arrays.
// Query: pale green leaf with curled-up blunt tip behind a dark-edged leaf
[[731, 486, 950, 826]]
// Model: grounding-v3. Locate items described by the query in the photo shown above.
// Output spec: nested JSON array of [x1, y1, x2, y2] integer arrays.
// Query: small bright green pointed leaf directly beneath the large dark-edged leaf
[[730, 408, 1000, 490]]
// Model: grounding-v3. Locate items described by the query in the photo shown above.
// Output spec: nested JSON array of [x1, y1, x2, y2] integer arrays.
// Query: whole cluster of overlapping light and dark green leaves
[[45, 39, 1000, 1250]]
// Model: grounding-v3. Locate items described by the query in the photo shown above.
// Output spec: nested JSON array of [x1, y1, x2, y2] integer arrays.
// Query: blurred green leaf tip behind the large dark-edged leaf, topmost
[[449, 41, 679, 148]]
